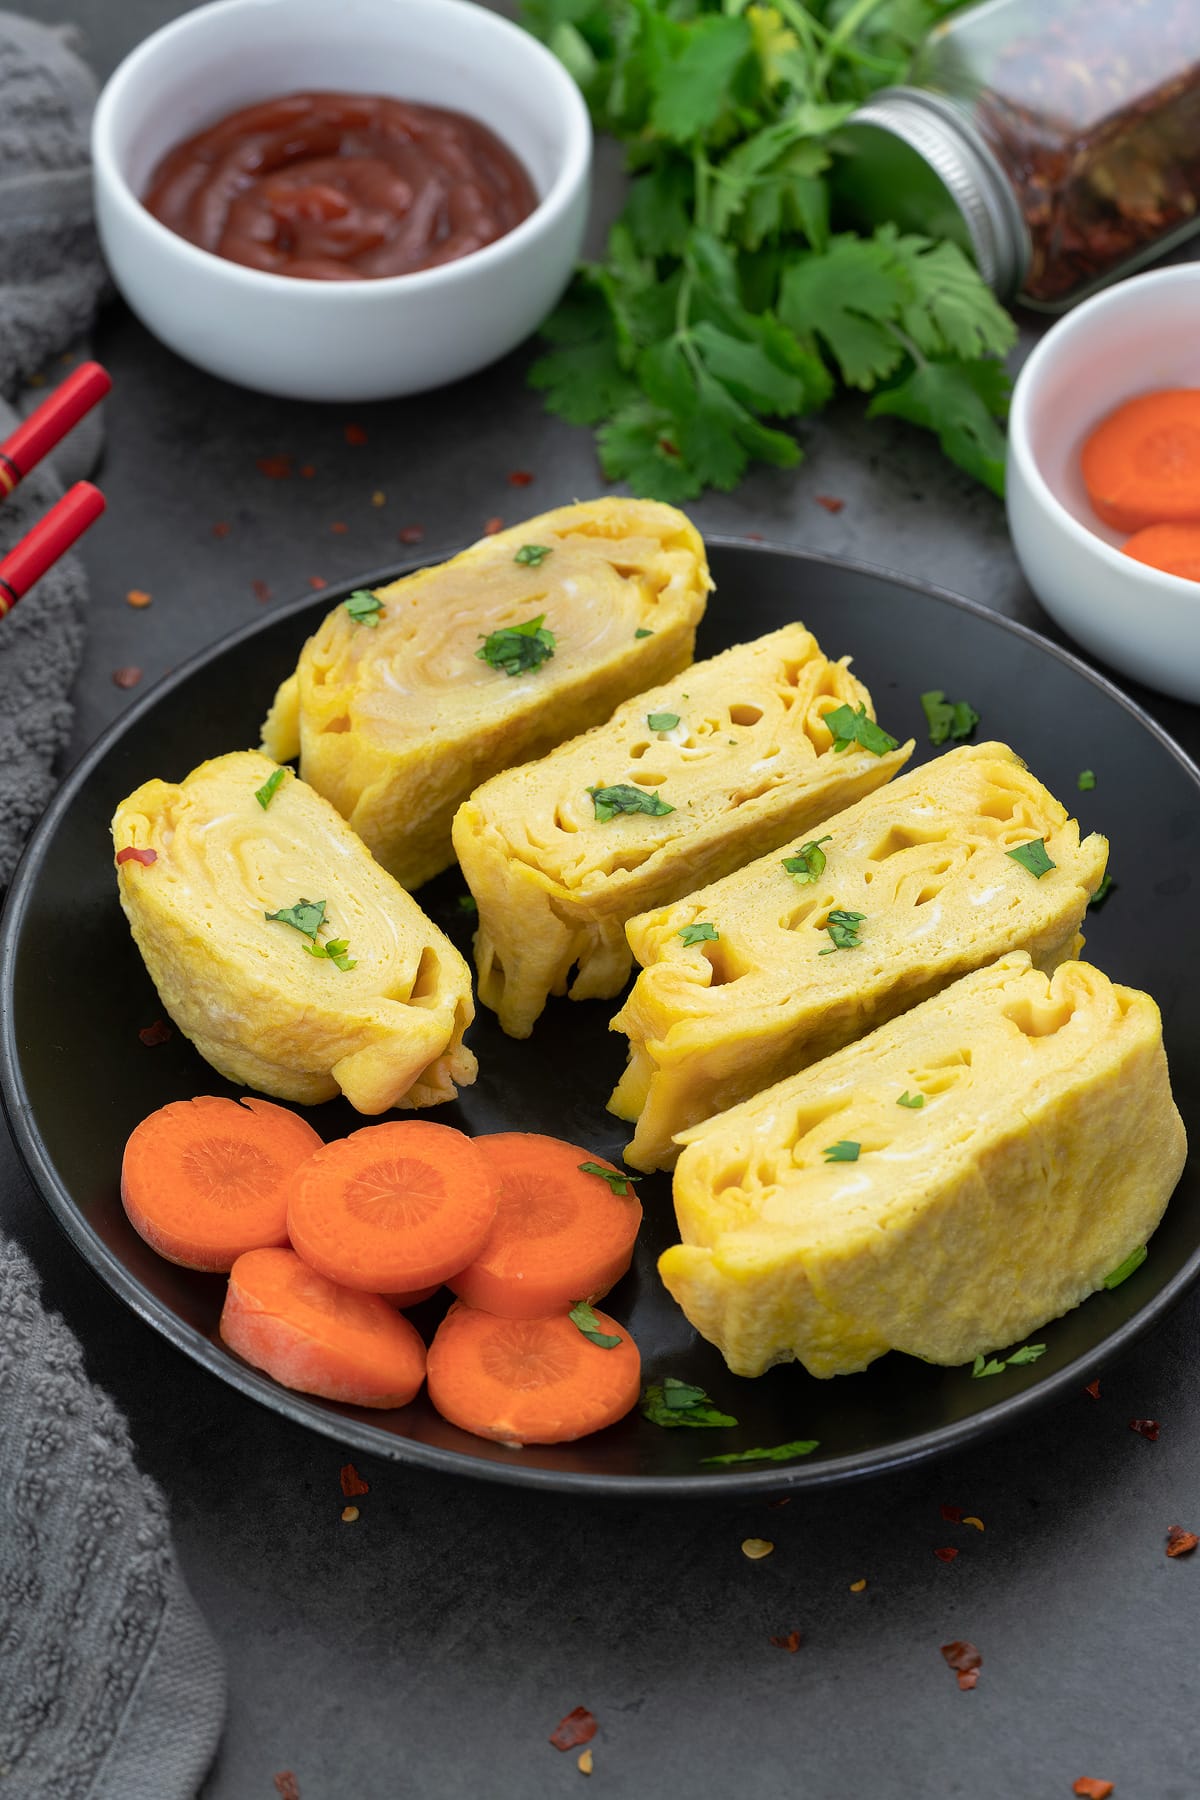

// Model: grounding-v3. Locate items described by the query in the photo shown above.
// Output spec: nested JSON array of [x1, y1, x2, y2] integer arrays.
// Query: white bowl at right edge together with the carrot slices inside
[[1007, 263, 1200, 702]]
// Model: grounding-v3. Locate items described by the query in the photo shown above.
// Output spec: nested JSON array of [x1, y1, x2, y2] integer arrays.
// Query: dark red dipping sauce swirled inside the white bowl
[[144, 94, 538, 281]]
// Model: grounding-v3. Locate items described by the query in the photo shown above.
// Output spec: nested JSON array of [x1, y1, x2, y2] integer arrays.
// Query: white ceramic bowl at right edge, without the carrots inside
[[1007, 263, 1200, 702]]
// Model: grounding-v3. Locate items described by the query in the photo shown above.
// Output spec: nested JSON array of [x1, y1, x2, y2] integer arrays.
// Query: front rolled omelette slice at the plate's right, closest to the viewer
[[658, 950, 1187, 1375]]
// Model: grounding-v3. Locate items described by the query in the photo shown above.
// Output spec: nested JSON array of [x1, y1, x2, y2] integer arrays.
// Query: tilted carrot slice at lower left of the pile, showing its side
[[221, 1249, 425, 1406]]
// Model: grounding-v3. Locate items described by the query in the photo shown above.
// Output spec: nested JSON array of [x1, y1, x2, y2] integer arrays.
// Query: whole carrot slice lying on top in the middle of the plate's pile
[[288, 1120, 500, 1294]]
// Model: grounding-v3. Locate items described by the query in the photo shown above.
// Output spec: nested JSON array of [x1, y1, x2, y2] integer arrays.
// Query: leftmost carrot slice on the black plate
[[121, 1094, 322, 1271]]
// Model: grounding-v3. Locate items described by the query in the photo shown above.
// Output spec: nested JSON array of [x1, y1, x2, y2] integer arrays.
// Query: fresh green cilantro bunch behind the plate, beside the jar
[[525, 0, 1015, 500]]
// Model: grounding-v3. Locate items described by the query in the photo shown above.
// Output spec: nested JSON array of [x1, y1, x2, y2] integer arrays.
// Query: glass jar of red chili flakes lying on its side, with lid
[[835, 0, 1200, 311]]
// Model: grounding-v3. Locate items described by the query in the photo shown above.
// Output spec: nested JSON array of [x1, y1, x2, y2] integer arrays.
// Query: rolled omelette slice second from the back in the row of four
[[453, 625, 912, 1037]]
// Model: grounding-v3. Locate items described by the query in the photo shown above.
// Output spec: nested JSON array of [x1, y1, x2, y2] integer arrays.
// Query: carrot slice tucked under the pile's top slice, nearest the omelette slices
[[448, 1130, 642, 1319]]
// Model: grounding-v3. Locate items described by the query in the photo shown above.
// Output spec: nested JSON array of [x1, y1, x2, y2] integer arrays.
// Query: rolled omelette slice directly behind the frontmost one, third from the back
[[608, 743, 1108, 1168]]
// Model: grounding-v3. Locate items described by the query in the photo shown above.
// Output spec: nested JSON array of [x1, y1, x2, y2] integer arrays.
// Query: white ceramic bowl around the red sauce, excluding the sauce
[[92, 0, 592, 401]]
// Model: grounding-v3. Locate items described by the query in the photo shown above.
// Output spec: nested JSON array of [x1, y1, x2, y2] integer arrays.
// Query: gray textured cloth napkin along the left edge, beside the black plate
[[0, 13, 225, 1800]]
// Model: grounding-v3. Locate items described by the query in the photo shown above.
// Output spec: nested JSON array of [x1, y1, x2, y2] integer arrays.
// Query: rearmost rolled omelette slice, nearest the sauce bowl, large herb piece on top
[[263, 499, 712, 887]]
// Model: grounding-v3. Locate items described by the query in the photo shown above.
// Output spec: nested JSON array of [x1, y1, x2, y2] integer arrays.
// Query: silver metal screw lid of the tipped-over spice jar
[[838, 86, 1033, 301]]
